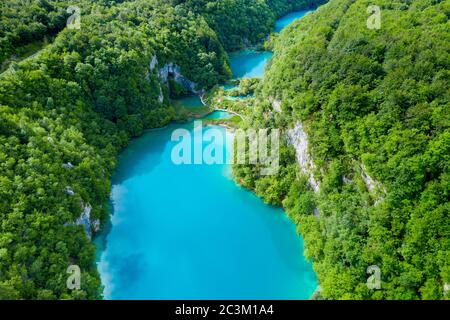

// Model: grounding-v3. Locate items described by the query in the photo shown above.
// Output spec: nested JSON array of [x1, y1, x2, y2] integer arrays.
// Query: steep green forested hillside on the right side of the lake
[[234, 0, 450, 299]]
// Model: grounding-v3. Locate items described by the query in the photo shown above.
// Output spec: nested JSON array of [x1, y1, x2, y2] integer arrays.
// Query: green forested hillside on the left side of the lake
[[0, 0, 318, 299]]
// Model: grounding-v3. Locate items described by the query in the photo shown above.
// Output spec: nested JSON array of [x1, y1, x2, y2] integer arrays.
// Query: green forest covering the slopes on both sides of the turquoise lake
[[0, 0, 450, 300]]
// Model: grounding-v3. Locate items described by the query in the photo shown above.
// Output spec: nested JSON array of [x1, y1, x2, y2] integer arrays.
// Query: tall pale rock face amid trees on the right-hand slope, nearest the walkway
[[287, 121, 320, 192]]
